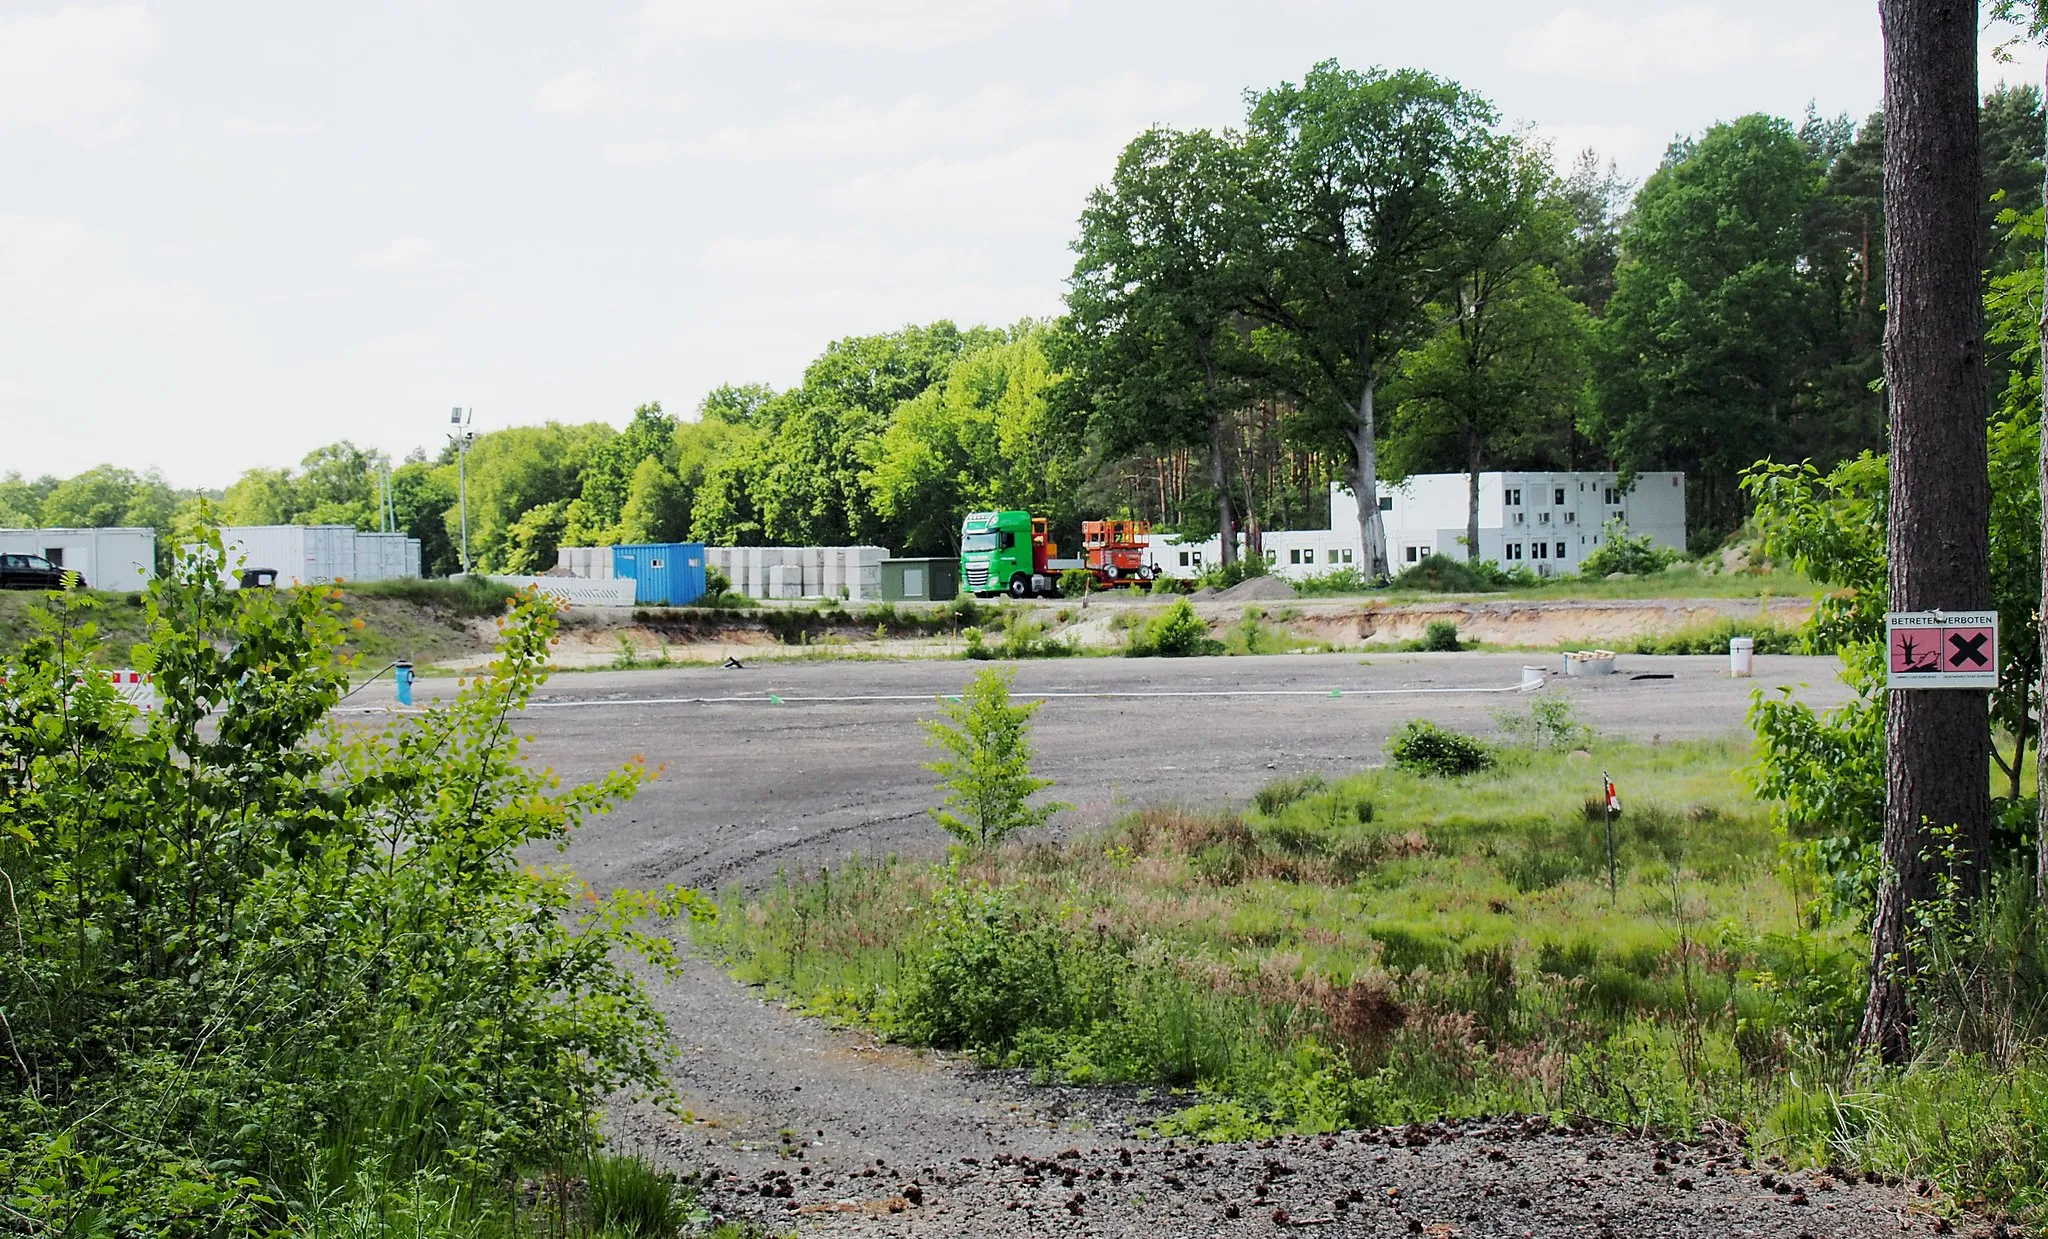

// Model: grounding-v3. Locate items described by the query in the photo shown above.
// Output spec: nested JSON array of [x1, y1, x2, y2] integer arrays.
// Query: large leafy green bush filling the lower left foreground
[[0, 530, 707, 1237]]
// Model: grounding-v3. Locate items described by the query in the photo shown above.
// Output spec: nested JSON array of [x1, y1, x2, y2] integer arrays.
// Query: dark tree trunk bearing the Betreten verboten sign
[[1860, 0, 1991, 1063]]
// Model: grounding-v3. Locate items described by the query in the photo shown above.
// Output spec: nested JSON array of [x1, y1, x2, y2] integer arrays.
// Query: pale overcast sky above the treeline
[[12, 0, 2042, 485]]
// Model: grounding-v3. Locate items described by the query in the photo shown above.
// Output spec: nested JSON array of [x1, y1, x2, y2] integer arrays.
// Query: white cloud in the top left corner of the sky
[[0, 4, 156, 137]]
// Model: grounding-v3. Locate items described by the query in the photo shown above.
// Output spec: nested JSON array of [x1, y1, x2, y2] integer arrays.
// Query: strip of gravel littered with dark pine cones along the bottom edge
[[707, 1118, 1966, 1239]]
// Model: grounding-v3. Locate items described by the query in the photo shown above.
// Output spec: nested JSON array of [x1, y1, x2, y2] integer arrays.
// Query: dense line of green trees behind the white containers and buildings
[[0, 66, 2042, 573]]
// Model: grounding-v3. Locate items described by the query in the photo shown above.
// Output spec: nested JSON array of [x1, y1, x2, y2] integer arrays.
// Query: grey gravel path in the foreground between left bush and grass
[[608, 958, 1966, 1239]]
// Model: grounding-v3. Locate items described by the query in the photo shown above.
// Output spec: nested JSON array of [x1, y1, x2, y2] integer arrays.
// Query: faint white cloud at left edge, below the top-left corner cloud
[[0, 215, 205, 330]]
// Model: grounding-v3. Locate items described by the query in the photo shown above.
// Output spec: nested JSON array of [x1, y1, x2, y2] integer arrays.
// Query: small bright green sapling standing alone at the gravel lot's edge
[[926, 668, 1069, 850]]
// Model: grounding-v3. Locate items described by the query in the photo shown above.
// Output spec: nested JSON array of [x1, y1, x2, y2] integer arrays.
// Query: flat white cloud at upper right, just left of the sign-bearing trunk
[[1501, 6, 1829, 84]]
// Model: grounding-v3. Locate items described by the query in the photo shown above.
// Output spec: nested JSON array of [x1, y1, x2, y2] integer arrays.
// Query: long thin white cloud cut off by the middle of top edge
[[639, 0, 1073, 51]]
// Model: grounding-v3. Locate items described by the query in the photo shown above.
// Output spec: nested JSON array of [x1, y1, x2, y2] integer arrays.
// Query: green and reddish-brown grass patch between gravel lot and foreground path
[[698, 733, 2048, 1216]]
